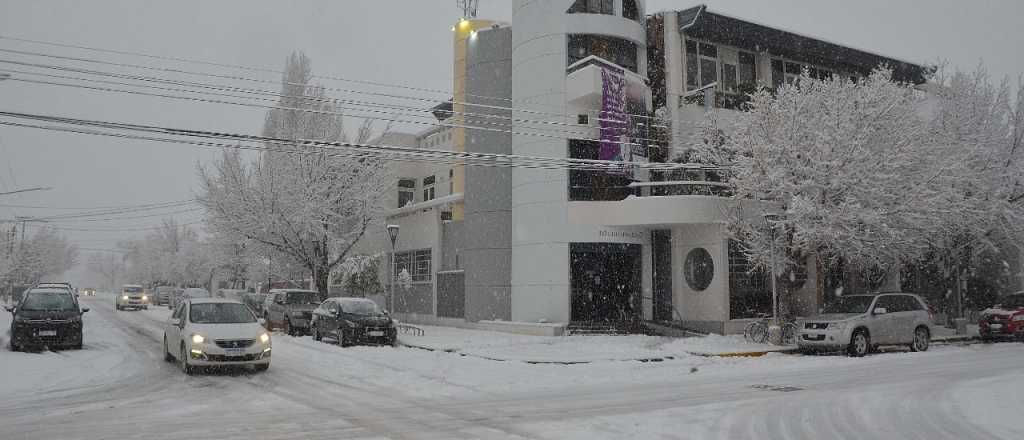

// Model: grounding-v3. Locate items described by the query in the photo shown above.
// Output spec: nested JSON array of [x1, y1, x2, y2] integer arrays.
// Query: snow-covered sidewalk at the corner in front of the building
[[398, 325, 793, 363]]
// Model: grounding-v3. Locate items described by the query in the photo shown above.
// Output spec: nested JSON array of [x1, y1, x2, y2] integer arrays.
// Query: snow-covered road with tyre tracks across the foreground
[[0, 296, 1024, 440]]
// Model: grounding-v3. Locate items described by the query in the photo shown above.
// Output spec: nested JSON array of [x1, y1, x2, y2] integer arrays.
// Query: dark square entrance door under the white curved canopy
[[569, 243, 641, 322]]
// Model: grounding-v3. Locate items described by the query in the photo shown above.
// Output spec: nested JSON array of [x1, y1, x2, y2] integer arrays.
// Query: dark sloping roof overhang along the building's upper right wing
[[678, 5, 934, 84]]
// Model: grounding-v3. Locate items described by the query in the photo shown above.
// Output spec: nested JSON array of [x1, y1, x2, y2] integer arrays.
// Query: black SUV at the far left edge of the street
[[5, 288, 89, 351]]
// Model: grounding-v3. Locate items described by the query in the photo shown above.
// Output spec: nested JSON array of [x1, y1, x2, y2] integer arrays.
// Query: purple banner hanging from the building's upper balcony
[[597, 69, 630, 171]]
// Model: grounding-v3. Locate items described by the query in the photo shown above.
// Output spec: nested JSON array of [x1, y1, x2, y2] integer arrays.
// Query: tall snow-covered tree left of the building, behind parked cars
[[199, 54, 388, 297]]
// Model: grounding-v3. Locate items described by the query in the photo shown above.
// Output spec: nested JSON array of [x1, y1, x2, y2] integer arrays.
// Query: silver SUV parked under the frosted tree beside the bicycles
[[797, 294, 932, 357]]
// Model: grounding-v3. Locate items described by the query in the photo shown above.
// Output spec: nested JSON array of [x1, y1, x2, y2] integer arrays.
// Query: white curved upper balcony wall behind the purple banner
[[565, 55, 651, 112]]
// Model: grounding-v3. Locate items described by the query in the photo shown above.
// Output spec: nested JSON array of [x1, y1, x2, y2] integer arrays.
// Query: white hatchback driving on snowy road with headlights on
[[164, 298, 270, 375]]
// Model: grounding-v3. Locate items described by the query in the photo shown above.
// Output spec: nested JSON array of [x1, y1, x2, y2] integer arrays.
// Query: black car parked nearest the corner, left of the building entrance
[[311, 298, 398, 347]]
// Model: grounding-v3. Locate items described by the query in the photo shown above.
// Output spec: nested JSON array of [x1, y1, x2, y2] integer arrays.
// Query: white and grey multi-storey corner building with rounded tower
[[348, 0, 925, 333]]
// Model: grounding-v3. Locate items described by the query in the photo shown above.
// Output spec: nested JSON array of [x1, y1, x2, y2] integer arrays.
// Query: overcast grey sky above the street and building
[[0, 0, 1024, 284]]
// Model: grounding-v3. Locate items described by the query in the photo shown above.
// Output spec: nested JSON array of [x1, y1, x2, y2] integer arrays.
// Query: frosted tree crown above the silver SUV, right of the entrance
[[696, 70, 968, 273]]
